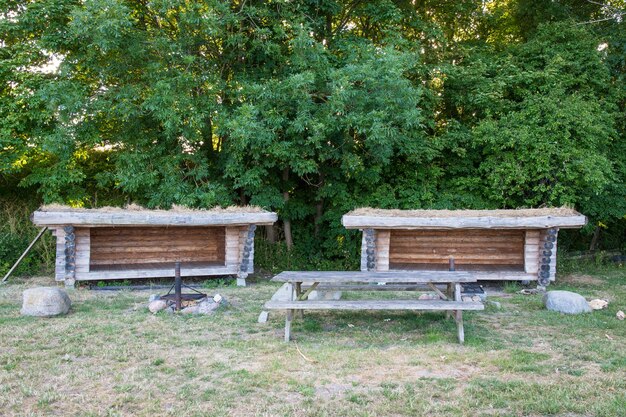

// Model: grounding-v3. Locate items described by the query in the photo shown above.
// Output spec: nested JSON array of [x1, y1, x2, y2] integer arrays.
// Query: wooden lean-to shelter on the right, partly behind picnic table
[[342, 208, 587, 286]]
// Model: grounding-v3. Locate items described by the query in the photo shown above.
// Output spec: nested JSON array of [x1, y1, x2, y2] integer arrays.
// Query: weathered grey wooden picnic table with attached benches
[[265, 271, 484, 344]]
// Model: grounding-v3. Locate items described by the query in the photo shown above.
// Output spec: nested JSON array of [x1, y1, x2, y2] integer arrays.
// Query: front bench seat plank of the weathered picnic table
[[265, 300, 485, 311]]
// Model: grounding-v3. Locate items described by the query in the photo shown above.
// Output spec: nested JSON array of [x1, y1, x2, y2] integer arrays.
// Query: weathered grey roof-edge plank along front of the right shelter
[[341, 215, 587, 229]]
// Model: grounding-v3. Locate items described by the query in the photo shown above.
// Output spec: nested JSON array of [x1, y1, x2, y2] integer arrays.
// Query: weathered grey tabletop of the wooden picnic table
[[272, 271, 476, 283]]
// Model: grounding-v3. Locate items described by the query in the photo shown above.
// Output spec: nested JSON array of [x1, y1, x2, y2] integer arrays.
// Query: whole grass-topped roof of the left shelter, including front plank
[[32, 204, 277, 227]]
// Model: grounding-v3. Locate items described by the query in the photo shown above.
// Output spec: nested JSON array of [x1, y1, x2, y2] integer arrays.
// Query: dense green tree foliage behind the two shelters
[[0, 0, 626, 272]]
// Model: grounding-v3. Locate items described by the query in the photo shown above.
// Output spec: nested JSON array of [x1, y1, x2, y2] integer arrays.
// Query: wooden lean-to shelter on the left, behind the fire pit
[[32, 206, 277, 285]]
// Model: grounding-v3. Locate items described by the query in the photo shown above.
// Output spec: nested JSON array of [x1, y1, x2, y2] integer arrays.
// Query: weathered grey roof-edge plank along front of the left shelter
[[33, 210, 278, 226]]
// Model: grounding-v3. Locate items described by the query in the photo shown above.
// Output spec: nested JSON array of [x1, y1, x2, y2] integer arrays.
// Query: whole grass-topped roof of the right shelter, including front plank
[[342, 207, 587, 229]]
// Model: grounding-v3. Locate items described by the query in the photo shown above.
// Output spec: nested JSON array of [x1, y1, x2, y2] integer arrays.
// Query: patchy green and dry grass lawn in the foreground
[[0, 268, 626, 416]]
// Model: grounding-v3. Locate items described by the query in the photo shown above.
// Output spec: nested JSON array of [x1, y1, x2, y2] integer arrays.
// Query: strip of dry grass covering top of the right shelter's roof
[[346, 207, 581, 218]]
